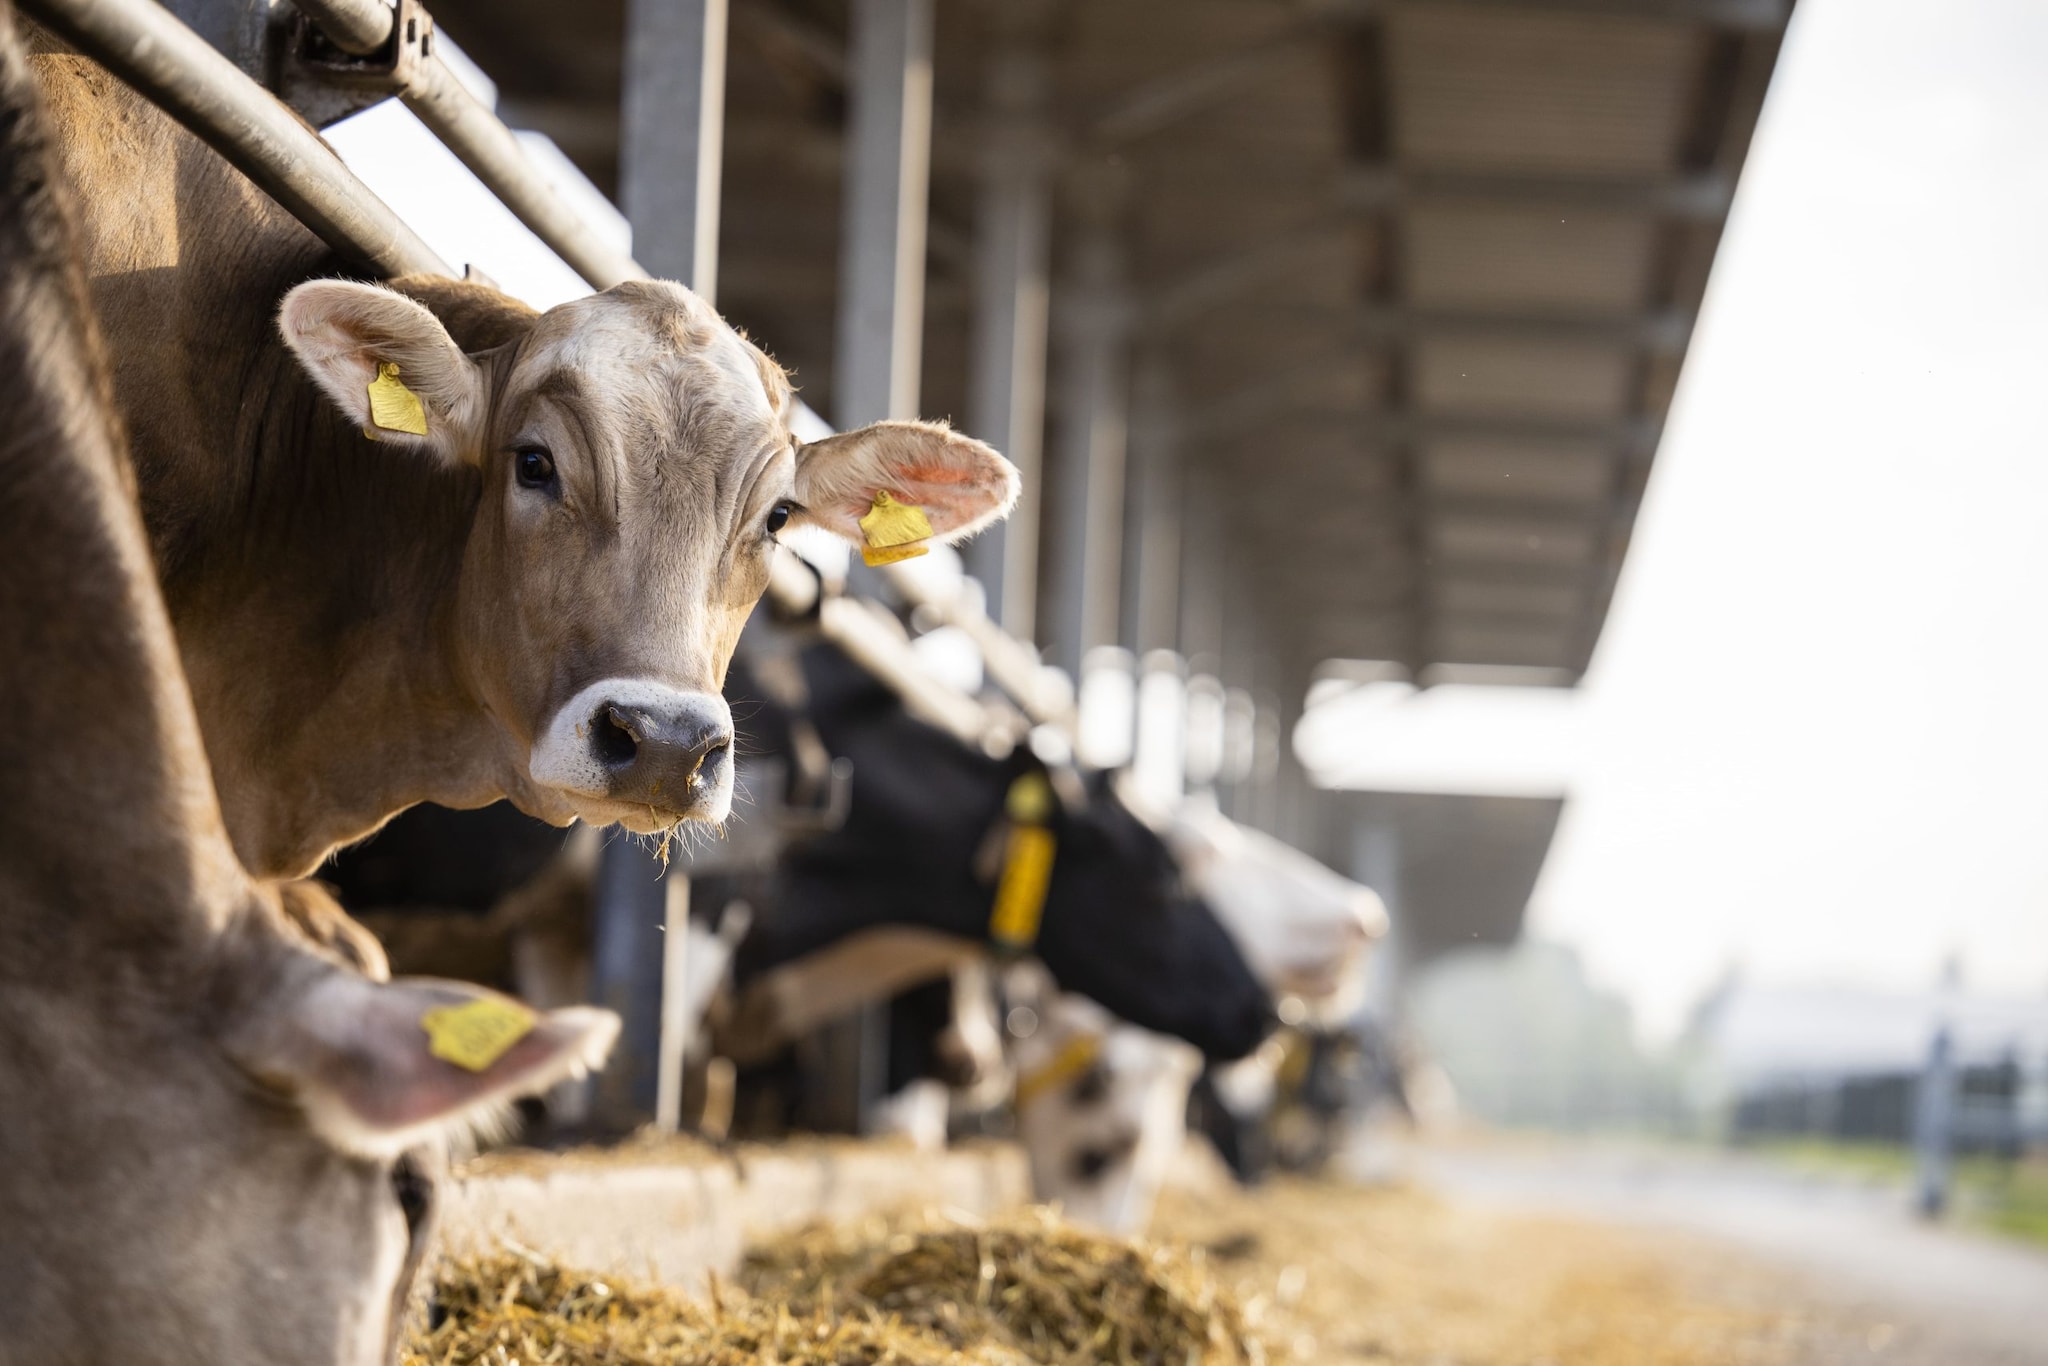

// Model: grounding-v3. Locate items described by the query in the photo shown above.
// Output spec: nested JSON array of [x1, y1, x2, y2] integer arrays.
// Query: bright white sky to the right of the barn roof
[[1303, 0, 2048, 1032]]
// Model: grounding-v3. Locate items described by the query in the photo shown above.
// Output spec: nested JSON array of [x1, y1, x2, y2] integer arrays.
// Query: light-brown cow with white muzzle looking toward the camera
[[39, 53, 1016, 877]]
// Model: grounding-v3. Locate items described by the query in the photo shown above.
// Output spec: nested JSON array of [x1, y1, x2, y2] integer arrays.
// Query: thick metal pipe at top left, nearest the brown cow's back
[[20, 0, 453, 274]]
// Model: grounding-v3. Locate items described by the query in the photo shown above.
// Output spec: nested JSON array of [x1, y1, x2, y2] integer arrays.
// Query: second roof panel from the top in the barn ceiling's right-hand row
[[1403, 205, 1657, 313]]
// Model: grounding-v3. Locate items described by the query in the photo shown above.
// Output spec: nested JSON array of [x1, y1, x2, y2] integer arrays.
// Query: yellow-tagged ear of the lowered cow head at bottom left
[[225, 965, 618, 1157]]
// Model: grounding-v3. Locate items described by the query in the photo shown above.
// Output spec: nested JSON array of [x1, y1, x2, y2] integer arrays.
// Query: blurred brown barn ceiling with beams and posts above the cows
[[419, 0, 1792, 952]]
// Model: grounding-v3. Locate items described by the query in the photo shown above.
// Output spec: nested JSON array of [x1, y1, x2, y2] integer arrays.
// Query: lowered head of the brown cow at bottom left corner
[[0, 917, 618, 1366]]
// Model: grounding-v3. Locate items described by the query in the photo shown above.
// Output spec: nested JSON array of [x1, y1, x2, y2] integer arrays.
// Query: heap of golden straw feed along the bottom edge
[[403, 1212, 1266, 1366]]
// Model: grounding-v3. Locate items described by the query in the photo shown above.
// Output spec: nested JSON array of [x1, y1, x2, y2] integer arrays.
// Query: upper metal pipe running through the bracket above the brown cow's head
[[295, 0, 647, 289]]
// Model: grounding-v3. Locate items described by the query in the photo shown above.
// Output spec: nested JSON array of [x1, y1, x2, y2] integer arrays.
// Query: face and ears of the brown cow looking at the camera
[[279, 281, 1016, 834]]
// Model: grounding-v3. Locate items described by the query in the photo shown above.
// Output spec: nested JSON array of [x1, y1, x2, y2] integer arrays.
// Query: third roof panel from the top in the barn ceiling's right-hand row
[[1415, 338, 1634, 418]]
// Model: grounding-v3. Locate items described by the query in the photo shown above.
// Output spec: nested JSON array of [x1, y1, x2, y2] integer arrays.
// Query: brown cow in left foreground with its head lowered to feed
[[0, 13, 616, 1366]]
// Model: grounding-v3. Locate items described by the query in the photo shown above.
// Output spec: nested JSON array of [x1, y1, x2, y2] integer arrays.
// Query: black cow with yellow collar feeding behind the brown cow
[[729, 645, 1274, 1059]]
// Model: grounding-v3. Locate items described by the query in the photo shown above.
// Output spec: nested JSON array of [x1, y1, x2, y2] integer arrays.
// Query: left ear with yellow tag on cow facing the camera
[[276, 281, 485, 461]]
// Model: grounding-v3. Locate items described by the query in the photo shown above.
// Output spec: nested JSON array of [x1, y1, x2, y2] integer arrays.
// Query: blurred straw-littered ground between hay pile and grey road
[[1153, 1180, 1966, 1366]]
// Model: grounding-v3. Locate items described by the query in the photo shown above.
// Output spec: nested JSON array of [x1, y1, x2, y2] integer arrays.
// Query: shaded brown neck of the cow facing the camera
[[166, 344, 506, 877]]
